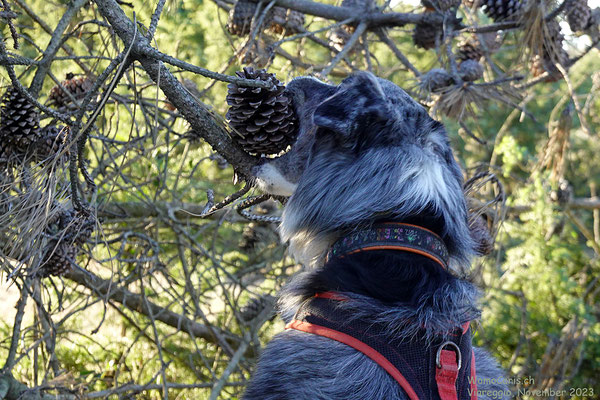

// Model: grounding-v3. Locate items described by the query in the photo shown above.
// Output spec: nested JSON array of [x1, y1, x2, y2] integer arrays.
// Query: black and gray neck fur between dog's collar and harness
[[279, 222, 479, 335]]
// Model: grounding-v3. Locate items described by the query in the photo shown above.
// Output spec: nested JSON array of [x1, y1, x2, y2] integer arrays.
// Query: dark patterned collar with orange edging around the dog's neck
[[326, 222, 448, 269]]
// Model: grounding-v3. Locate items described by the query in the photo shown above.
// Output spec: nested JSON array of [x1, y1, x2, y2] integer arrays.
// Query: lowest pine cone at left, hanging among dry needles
[[39, 210, 95, 277]]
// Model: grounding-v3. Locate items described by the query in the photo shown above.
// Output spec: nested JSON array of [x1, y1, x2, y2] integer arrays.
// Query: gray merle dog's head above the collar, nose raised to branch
[[254, 72, 473, 267]]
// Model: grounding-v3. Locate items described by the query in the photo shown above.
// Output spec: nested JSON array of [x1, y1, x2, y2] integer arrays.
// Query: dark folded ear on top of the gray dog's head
[[313, 72, 390, 136]]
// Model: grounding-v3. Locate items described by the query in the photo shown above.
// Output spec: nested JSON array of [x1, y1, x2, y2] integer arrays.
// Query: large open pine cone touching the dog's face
[[227, 67, 298, 155]]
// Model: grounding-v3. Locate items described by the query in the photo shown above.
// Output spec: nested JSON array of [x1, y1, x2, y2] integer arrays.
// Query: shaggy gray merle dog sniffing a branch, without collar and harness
[[243, 72, 511, 400]]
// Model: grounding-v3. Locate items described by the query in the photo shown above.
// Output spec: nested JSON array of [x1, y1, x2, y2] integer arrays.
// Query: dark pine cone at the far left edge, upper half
[[0, 88, 40, 152]]
